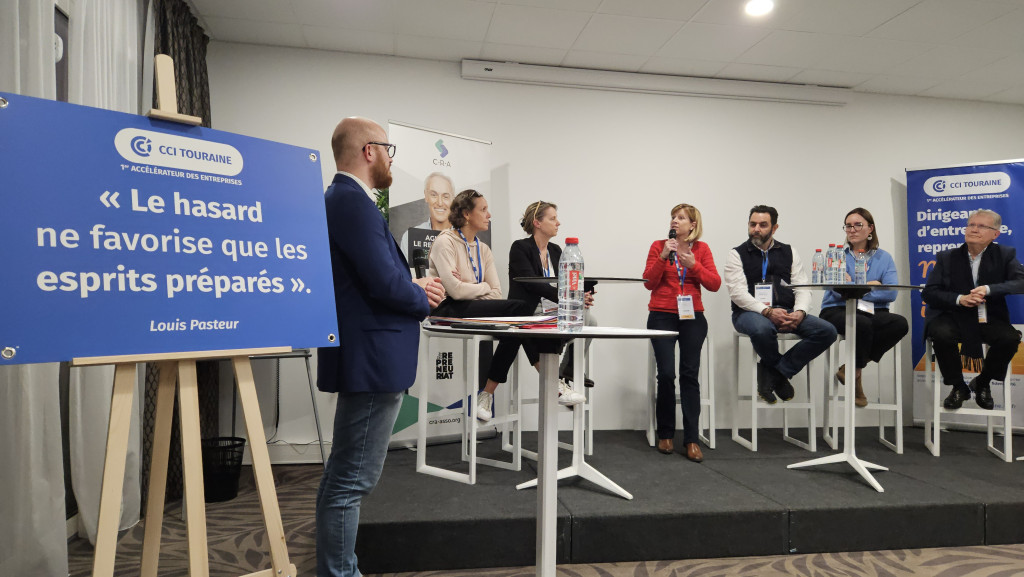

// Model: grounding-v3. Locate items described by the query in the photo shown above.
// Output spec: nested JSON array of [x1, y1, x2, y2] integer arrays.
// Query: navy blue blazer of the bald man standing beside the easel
[[316, 174, 430, 393]]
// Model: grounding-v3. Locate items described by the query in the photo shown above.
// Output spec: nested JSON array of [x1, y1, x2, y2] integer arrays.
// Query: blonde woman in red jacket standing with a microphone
[[643, 204, 722, 462]]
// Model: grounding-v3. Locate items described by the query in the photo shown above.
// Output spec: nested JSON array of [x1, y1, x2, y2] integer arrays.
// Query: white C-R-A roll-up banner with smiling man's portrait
[[388, 121, 499, 444]]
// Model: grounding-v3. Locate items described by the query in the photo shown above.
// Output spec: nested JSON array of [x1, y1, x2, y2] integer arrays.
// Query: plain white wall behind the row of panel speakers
[[208, 42, 1024, 446]]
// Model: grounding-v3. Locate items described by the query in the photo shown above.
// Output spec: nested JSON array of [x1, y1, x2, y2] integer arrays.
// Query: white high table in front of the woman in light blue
[[787, 284, 922, 493]]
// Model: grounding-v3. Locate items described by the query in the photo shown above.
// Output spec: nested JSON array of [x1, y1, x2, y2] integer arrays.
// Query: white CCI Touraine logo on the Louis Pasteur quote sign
[[114, 128, 243, 176]]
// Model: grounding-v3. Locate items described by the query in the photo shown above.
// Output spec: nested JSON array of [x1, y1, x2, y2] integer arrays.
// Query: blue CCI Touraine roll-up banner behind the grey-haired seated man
[[906, 159, 1024, 426]]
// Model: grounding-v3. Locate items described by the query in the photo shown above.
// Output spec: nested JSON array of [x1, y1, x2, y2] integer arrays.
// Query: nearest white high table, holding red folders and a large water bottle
[[423, 325, 677, 577]]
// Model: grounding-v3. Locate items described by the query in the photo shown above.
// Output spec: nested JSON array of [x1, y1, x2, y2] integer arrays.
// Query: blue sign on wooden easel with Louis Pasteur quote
[[0, 93, 338, 364]]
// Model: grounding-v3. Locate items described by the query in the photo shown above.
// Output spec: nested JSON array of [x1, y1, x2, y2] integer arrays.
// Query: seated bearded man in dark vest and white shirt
[[725, 205, 836, 405]]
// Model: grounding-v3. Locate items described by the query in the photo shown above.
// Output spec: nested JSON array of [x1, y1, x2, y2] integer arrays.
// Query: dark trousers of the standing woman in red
[[647, 311, 715, 444]]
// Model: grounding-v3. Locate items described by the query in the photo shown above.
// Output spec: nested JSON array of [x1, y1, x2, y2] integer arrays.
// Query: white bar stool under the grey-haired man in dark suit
[[925, 338, 1014, 463]]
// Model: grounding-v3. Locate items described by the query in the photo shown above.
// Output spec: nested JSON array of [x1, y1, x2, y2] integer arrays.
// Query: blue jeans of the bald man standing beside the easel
[[316, 393, 403, 577]]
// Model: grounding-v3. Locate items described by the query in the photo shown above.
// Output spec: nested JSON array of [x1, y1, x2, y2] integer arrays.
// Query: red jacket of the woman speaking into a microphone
[[643, 241, 722, 313]]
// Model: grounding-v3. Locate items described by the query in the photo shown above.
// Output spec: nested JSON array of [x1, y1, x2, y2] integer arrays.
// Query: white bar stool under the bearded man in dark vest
[[732, 330, 817, 453]]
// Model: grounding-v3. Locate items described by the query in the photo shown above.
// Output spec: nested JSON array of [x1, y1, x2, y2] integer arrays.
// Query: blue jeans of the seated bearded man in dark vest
[[732, 311, 836, 379]]
